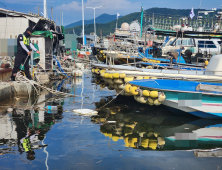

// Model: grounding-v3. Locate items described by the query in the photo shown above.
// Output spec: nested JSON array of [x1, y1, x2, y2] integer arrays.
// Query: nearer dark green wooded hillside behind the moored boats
[[65, 8, 207, 36]]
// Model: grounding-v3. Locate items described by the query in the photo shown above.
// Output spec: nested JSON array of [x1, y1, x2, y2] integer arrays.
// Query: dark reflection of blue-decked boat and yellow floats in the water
[[92, 96, 222, 150]]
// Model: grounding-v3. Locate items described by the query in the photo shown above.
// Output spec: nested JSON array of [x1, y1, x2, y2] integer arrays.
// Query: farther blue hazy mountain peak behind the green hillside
[[65, 14, 121, 28]]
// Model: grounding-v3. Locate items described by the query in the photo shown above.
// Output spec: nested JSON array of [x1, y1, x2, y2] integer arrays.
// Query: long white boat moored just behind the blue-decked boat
[[92, 55, 222, 82]]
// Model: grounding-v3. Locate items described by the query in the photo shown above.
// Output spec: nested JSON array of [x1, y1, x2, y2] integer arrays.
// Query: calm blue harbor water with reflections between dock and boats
[[0, 72, 222, 170]]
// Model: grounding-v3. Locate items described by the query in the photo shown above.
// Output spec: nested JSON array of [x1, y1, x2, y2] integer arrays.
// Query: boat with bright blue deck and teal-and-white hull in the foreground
[[130, 79, 222, 118]]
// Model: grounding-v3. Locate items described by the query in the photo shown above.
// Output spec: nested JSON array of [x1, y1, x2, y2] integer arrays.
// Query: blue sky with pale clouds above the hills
[[0, 0, 222, 25]]
